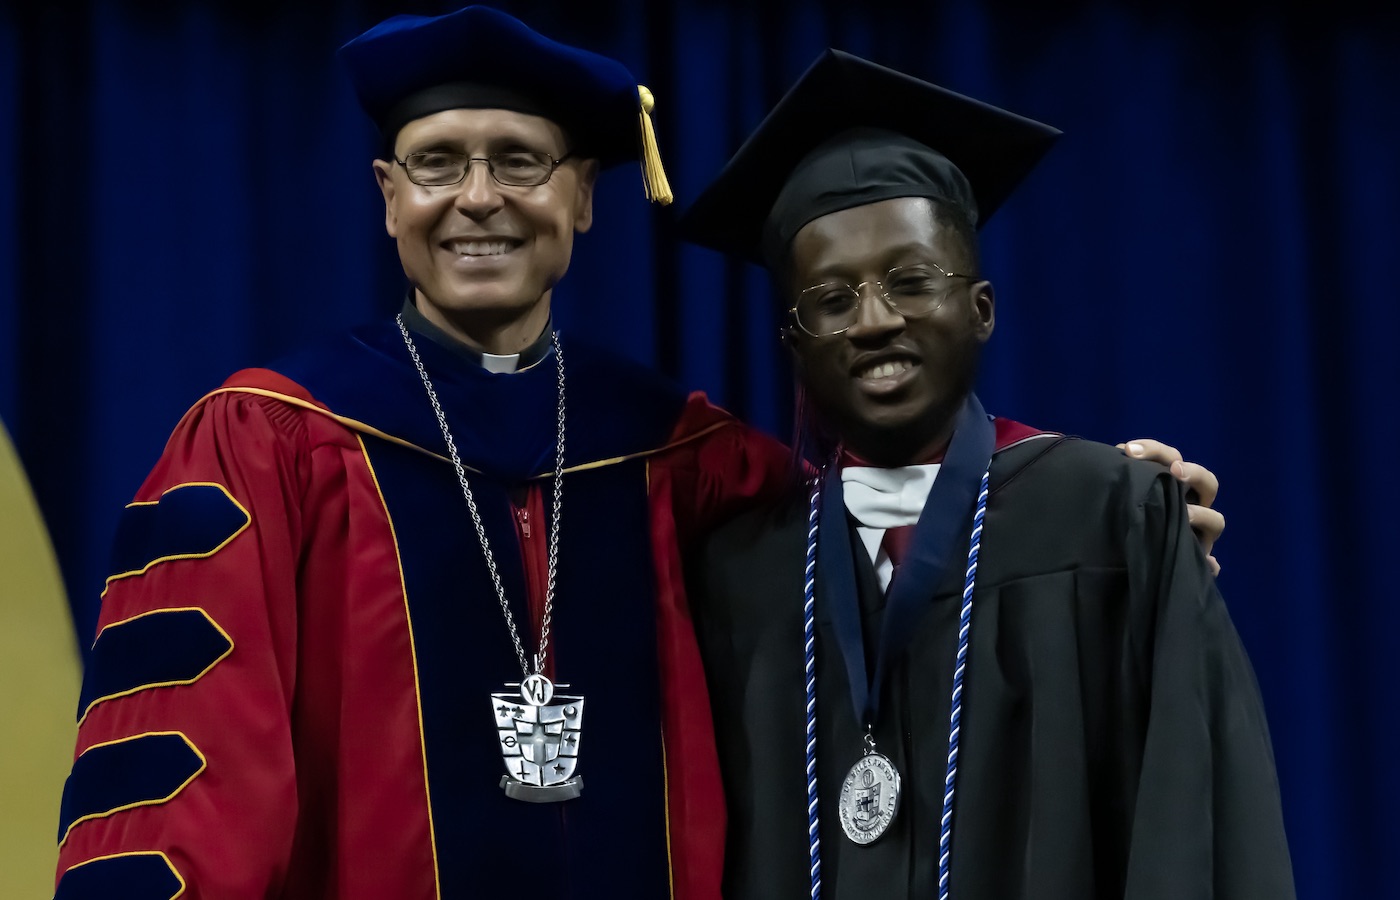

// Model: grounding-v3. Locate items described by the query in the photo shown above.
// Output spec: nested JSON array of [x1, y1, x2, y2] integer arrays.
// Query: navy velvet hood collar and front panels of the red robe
[[274, 322, 686, 899]]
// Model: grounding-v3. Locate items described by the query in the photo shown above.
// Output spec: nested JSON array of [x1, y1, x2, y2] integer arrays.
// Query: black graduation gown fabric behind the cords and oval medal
[[692, 437, 1294, 900]]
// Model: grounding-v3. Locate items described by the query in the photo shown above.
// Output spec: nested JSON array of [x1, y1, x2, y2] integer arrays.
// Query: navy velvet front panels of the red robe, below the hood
[[365, 440, 668, 897]]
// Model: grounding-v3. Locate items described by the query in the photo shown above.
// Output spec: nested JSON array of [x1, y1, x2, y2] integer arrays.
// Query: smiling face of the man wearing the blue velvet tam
[[374, 109, 598, 353]]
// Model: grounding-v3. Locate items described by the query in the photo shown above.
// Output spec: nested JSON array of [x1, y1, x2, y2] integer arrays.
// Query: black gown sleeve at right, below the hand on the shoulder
[[1124, 467, 1295, 900]]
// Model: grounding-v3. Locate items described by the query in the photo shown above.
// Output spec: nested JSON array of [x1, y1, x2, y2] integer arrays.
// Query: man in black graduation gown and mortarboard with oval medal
[[682, 52, 1294, 900]]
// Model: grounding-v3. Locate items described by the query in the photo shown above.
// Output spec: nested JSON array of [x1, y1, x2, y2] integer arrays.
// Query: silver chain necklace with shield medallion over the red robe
[[395, 314, 584, 802]]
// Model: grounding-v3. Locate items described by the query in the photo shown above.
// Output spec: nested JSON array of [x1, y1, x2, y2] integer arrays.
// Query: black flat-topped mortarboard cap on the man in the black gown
[[679, 50, 1060, 265]]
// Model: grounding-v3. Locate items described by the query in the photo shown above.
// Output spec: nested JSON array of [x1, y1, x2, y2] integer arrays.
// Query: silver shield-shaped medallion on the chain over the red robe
[[491, 675, 584, 803]]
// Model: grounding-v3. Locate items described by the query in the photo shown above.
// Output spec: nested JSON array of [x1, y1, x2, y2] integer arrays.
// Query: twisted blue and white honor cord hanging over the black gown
[[802, 470, 991, 900]]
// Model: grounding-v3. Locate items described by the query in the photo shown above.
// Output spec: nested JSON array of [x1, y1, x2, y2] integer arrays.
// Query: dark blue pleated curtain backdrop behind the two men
[[0, 0, 1400, 900]]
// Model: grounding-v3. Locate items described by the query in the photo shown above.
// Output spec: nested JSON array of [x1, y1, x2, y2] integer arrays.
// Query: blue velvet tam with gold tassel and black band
[[340, 6, 671, 203]]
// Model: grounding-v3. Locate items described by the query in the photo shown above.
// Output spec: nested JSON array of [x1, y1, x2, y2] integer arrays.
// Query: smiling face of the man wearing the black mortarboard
[[788, 197, 994, 466]]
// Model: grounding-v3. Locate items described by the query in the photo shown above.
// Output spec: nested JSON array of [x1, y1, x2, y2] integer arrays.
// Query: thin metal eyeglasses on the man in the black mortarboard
[[788, 263, 977, 337]]
